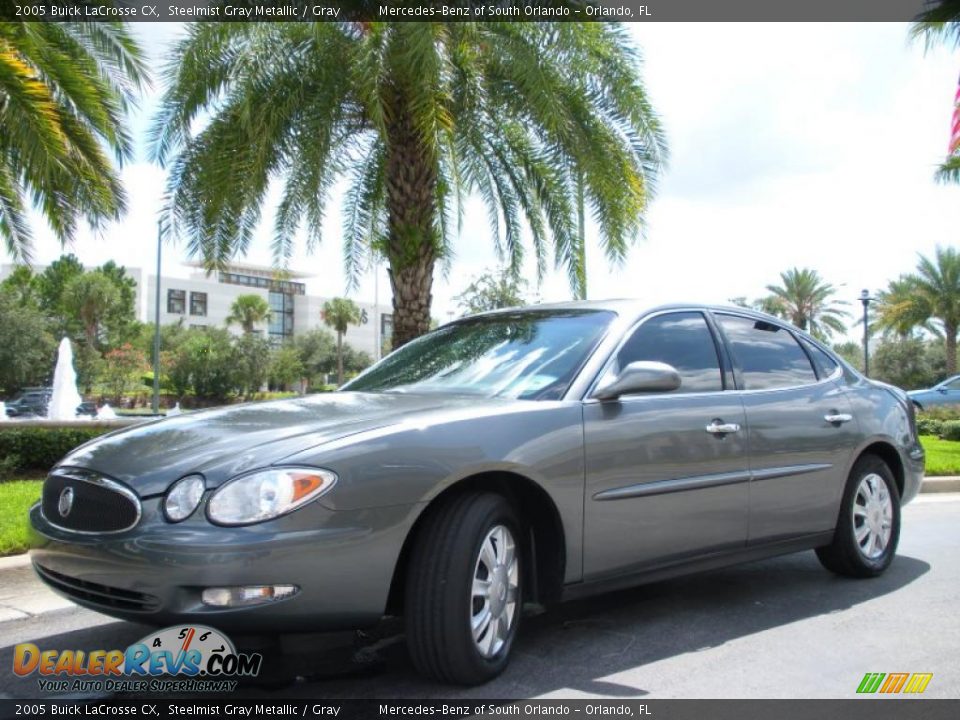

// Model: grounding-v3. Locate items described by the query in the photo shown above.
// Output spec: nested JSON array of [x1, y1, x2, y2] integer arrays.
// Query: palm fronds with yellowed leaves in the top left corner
[[0, 22, 146, 262]]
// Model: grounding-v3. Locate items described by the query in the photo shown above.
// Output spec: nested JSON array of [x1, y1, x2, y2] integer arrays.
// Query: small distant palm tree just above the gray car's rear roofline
[[757, 268, 849, 340]]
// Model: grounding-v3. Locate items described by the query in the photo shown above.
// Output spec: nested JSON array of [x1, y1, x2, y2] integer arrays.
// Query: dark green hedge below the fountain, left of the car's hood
[[0, 423, 122, 479]]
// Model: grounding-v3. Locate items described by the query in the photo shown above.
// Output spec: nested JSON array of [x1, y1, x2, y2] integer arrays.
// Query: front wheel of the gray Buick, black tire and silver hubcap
[[406, 493, 523, 685]]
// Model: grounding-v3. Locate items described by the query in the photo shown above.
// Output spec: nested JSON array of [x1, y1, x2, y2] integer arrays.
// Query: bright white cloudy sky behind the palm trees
[[11, 23, 960, 337]]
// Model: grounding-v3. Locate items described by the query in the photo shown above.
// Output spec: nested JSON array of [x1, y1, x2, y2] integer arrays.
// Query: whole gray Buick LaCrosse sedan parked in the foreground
[[30, 301, 923, 684]]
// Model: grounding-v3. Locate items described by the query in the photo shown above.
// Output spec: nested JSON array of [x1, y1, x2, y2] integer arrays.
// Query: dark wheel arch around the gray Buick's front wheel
[[386, 470, 567, 615]]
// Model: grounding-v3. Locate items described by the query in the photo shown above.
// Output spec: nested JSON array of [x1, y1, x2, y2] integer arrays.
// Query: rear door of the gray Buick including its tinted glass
[[715, 313, 858, 542]]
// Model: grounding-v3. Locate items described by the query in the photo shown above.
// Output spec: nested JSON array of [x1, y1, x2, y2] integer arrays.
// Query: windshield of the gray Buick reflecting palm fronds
[[343, 310, 614, 400]]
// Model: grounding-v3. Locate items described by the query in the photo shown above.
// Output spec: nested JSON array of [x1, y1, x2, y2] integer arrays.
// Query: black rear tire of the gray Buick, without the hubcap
[[817, 455, 900, 578]]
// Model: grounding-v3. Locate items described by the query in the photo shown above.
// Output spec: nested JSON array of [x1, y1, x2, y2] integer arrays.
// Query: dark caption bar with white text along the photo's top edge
[[0, 0, 935, 22]]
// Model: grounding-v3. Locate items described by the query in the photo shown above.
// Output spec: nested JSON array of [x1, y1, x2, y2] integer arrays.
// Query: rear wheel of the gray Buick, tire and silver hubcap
[[817, 455, 900, 578]]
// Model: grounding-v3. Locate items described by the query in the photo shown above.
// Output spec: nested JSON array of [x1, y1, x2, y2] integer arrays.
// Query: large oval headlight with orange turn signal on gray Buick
[[207, 468, 337, 525]]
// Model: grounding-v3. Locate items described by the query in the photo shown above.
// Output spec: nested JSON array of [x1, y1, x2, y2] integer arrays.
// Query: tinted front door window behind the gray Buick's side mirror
[[617, 312, 723, 393]]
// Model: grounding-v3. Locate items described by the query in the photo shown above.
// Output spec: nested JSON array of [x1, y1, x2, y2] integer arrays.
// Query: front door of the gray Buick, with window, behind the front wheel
[[583, 311, 749, 580]]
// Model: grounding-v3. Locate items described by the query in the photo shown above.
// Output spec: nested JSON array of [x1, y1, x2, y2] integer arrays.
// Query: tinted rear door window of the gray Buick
[[717, 315, 817, 390]]
